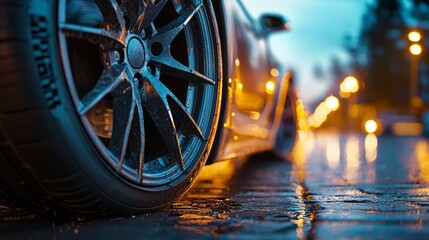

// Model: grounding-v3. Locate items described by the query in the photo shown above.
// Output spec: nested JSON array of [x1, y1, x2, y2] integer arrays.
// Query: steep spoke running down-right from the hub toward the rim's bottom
[[145, 78, 185, 170]]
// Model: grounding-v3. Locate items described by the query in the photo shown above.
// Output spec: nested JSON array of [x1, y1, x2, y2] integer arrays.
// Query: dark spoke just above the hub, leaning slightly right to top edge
[[133, 0, 168, 32]]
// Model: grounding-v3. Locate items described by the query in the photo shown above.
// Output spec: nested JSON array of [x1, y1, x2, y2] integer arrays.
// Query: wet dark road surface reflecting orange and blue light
[[0, 131, 429, 239]]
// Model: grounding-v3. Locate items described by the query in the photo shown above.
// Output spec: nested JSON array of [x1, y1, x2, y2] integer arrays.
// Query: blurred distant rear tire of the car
[[273, 87, 298, 159]]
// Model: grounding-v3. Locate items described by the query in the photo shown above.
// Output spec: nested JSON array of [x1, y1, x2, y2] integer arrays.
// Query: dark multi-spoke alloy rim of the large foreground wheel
[[58, 0, 220, 190]]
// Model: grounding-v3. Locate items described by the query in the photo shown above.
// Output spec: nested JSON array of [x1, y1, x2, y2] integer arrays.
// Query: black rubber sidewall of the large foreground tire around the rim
[[29, 0, 221, 212]]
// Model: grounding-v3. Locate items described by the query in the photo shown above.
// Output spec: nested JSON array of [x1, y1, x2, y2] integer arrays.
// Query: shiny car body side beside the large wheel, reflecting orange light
[[211, 0, 290, 160]]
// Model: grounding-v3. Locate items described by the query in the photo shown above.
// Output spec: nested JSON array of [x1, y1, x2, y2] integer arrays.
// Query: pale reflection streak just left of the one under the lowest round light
[[345, 137, 360, 182]]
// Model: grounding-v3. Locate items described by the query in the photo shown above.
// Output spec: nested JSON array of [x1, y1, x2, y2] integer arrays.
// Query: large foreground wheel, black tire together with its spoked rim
[[0, 0, 222, 216]]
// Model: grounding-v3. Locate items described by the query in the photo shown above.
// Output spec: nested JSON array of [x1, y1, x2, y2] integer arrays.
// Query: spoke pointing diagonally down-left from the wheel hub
[[78, 64, 125, 116]]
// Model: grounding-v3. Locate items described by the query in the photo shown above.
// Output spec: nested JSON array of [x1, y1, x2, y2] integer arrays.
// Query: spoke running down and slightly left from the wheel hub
[[108, 93, 136, 172]]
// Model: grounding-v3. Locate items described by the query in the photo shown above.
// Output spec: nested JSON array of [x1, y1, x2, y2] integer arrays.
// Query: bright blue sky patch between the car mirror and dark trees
[[242, 0, 370, 105]]
